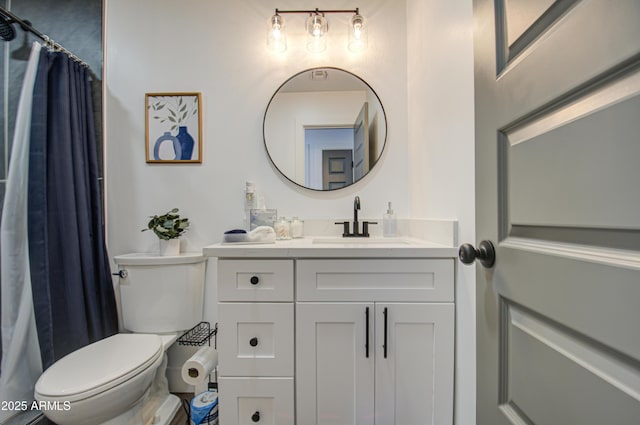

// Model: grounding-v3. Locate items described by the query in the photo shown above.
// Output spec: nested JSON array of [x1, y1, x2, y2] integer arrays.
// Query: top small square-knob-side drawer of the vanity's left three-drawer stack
[[218, 260, 293, 302]]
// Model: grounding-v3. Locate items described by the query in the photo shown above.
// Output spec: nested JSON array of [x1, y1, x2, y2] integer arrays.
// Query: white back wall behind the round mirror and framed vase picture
[[105, 0, 408, 255]]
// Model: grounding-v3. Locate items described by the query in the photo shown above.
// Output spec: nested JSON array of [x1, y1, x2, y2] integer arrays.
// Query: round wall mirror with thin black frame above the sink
[[263, 68, 387, 190]]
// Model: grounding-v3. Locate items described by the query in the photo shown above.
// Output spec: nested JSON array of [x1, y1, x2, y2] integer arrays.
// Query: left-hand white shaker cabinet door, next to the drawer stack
[[296, 303, 374, 425]]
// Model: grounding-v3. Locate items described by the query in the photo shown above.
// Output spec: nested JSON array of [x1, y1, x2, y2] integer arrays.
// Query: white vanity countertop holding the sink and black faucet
[[203, 237, 458, 258]]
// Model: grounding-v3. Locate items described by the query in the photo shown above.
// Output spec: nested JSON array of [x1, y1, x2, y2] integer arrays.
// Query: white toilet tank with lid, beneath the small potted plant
[[114, 253, 206, 333]]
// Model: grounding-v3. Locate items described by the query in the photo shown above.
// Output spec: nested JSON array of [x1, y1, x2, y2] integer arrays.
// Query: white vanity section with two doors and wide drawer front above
[[296, 259, 454, 425]]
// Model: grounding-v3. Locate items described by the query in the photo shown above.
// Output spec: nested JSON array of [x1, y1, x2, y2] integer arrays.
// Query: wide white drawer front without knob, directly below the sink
[[296, 259, 454, 302]]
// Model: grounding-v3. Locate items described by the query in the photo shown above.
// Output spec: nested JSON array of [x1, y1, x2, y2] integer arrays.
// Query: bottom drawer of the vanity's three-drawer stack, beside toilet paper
[[218, 378, 295, 425]]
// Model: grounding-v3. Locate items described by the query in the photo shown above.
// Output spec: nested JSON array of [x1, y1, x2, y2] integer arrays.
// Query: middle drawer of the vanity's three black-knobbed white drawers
[[218, 303, 294, 376]]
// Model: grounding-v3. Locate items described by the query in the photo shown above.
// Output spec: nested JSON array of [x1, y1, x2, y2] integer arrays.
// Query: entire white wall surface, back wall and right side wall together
[[104, 0, 475, 425]]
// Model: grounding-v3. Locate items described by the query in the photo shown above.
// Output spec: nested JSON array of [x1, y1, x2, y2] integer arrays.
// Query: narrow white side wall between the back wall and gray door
[[407, 0, 476, 425]]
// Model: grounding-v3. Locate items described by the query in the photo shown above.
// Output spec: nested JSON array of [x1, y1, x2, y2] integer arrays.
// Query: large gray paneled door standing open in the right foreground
[[474, 0, 640, 425]]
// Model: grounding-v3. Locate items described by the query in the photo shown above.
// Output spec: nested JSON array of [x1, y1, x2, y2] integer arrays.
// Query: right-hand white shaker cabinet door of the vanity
[[375, 303, 454, 425]]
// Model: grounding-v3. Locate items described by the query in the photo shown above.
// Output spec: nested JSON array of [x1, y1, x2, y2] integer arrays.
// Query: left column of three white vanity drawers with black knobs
[[218, 259, 295, 425]]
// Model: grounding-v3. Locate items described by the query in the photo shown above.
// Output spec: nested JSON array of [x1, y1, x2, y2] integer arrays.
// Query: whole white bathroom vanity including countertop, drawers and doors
[[204, 238, 456, 425]]
